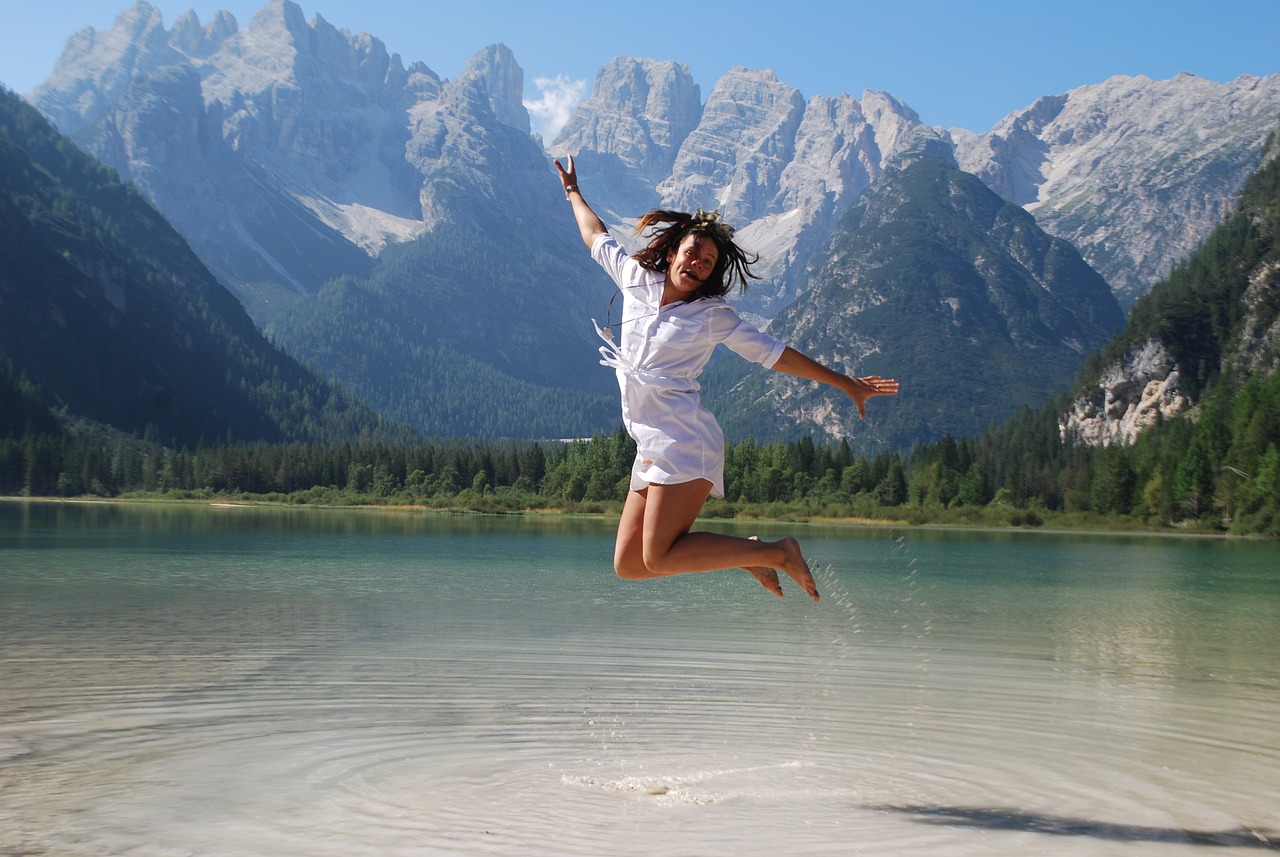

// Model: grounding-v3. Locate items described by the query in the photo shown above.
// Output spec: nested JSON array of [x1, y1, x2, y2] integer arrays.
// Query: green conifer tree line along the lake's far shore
[[0, 404, 1280, 536]]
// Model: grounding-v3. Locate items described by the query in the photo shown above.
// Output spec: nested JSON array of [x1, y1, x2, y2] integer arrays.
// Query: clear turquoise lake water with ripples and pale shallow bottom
[[0, 503, 1280, 856]]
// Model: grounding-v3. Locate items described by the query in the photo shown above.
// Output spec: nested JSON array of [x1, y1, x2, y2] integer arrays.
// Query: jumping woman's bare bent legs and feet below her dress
[[613, 480, 818, 601]]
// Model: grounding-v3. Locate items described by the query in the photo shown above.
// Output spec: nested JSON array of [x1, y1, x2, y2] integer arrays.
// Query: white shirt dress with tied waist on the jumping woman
[[591, 233, 786, 498]]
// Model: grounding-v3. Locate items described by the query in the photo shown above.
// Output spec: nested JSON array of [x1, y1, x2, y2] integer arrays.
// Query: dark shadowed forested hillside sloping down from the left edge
[[0, 91, 398, 445]]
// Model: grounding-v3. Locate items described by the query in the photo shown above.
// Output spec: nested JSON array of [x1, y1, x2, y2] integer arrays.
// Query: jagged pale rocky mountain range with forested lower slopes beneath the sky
[[10, 0, 1280, 444]]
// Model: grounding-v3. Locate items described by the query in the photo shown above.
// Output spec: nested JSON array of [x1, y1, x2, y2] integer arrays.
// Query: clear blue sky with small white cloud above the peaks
[[0, 0, 1280, 132]]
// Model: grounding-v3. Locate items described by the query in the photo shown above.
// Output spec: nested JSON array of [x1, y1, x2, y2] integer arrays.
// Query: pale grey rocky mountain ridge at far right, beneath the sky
[[952, 73, 1280, 306]]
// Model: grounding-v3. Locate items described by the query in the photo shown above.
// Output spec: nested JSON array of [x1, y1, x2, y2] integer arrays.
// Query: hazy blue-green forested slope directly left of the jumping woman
[[270, 227, 620, 437]]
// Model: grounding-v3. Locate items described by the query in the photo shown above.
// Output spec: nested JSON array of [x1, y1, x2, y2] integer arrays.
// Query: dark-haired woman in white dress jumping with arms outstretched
[[556, 157, 897, 601]]
